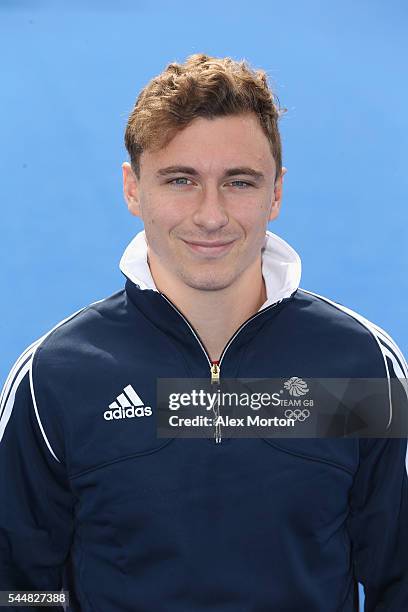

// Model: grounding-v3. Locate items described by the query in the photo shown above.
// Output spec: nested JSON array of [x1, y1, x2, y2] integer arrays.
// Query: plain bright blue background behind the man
[[0, 0, 408, 608]]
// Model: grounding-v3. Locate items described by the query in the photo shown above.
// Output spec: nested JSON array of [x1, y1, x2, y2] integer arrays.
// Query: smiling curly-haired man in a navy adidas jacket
[[0, 54, 408, 612]]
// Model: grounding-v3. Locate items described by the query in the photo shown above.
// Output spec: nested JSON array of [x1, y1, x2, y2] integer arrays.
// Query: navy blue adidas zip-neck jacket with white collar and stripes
[[0, 231, 408, 612]]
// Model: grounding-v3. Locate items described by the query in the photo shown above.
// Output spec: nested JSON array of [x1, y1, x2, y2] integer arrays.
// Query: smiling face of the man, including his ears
[[122, 114, 282, 291]]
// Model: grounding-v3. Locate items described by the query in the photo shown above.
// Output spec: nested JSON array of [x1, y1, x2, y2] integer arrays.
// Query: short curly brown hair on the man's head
[[125, 53, 287, 180]]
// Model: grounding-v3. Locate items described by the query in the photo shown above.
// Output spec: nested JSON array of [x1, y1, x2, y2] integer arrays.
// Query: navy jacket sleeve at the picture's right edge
[[348, 344, 408, 612]]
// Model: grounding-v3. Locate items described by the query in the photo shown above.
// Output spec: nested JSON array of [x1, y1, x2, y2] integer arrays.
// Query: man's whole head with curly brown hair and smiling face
[[122, 55, 286, 290]]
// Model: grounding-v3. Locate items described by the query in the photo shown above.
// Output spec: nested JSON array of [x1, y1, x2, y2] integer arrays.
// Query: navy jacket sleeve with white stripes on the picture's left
[[0, 350, 74, 612]]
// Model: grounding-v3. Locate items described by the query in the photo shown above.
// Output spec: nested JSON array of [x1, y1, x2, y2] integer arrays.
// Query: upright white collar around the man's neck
[[119, 230, 302, 312]]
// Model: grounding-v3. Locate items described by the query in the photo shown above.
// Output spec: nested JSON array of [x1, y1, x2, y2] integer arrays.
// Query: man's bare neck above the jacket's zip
[[150, 255, 267, 361]]
